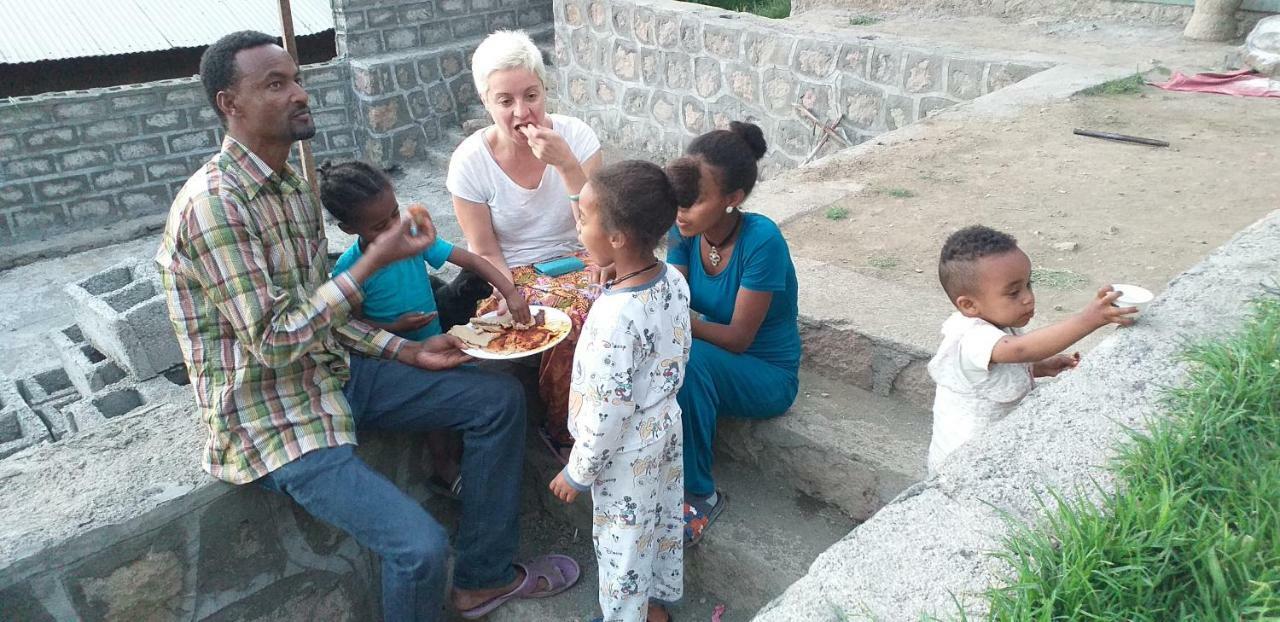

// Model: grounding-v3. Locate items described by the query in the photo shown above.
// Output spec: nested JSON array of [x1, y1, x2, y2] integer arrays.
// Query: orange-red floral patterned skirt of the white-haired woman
[[476, 253, 600, 445]]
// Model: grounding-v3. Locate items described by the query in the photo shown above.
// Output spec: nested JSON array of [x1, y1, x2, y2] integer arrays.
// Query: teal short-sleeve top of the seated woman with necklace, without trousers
[[667, 214, 800, 370]]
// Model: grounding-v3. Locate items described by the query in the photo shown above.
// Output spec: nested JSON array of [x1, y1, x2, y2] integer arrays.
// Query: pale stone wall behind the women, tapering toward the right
[[554, 0, 1050, 166]]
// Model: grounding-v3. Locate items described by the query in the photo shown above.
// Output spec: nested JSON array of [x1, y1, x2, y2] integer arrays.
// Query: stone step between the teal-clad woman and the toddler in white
[[794, 257, 954, 408]]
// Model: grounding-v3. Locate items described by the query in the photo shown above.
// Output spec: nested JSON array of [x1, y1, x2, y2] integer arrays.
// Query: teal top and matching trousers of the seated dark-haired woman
[[667, 214, 800, 498]]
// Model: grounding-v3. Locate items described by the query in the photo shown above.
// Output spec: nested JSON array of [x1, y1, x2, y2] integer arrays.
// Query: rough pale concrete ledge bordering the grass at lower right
[[755, 212, 1280, 622]]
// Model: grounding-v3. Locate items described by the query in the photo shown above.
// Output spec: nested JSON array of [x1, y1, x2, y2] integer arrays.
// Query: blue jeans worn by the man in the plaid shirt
[[259, 355, 525, 621]]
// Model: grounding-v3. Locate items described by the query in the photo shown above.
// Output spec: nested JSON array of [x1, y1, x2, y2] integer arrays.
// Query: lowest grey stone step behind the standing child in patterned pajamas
[[460, 445, 856, 622]]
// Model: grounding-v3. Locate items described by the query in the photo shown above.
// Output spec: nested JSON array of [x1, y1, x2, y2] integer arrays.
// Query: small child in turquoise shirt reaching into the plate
[[319, 160, 531, 498]]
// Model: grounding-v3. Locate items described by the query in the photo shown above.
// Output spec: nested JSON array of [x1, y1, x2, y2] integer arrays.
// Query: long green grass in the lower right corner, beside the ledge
[[987, 296, 1280, 621]]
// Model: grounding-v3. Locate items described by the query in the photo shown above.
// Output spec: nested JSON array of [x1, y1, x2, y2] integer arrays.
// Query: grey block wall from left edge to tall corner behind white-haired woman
[[0, 0, 553, 244]]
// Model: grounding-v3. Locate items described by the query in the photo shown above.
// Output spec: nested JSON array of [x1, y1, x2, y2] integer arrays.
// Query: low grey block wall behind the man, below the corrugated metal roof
[[0, 63, 355, 244]]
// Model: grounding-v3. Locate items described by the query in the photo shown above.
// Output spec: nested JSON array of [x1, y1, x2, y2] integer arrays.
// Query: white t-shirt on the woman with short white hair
[[445, 114, 600, 267]]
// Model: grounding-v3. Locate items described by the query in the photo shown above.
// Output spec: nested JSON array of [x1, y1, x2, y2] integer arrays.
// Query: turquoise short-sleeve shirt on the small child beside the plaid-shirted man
[[333, 237, 453, 342]]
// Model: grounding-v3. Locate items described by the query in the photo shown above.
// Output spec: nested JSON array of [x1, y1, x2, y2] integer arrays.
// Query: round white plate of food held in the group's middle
[[449, 305, 573, 360]]
